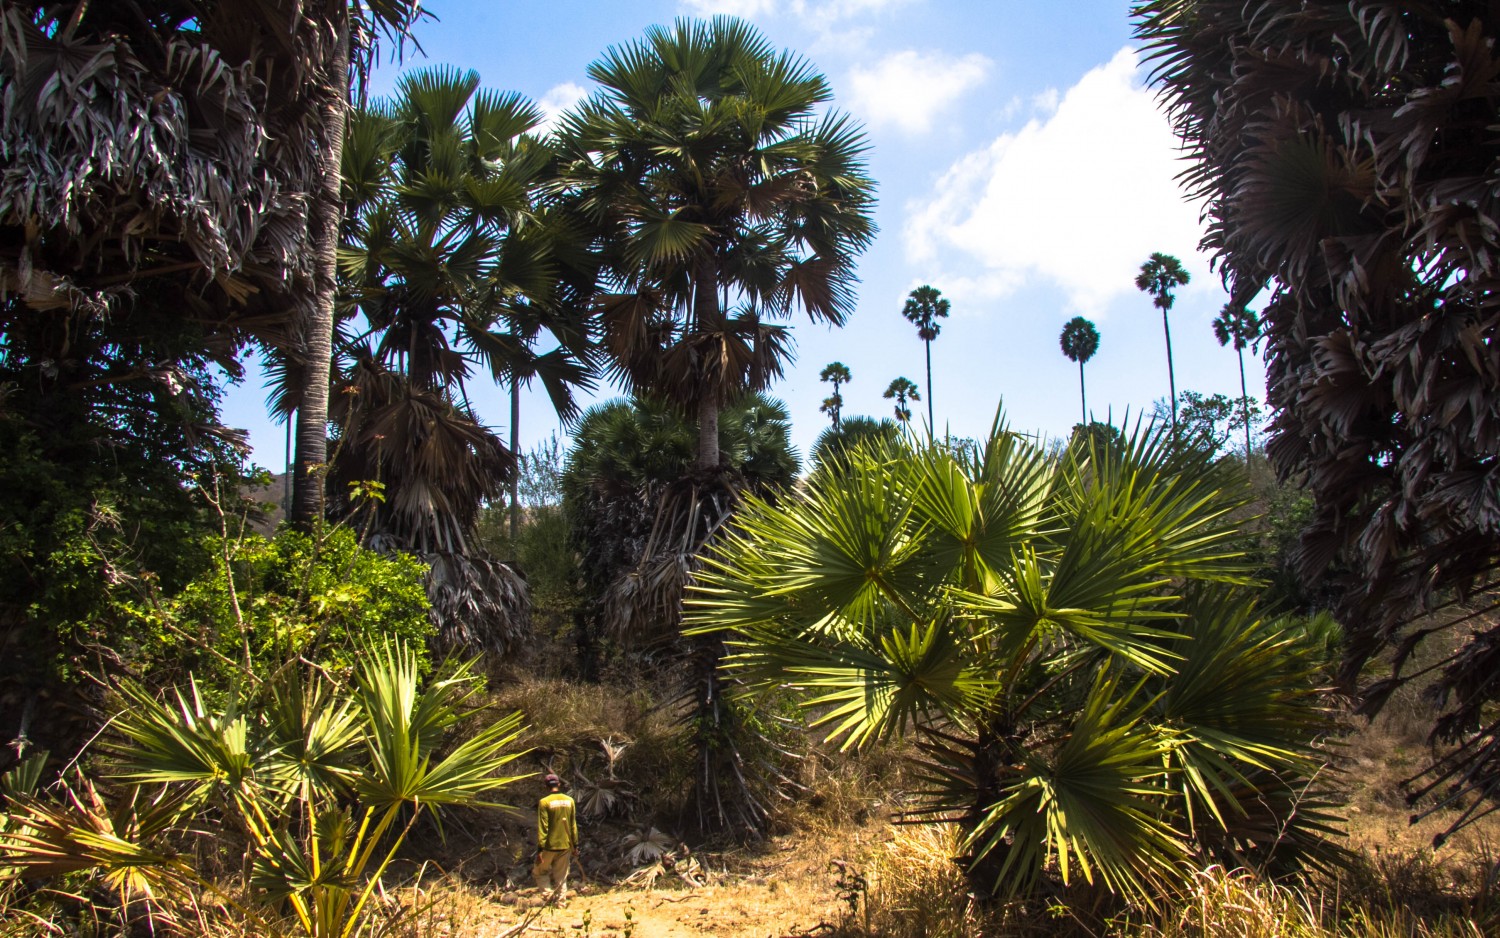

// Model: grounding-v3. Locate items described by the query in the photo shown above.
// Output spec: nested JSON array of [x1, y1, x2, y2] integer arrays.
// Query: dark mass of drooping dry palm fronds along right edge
[[1136, 0, 1500, 827]]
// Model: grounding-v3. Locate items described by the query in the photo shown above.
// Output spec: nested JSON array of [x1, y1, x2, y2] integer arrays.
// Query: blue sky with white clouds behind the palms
[[214, 0, 1265, 470]]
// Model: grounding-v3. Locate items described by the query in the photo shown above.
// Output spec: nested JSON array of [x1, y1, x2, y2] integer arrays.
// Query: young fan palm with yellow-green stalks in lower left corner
[[0, 644, 522, 938]]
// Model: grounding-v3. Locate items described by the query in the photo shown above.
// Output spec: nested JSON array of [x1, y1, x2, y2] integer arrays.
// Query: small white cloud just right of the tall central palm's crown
[[845, 50, 990, 134]]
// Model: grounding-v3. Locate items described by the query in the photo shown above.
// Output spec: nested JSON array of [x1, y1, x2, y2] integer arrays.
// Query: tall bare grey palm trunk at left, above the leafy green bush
[[291, 0, 350, 527]]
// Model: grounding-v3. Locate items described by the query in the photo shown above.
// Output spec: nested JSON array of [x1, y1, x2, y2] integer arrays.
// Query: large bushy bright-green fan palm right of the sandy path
[[689, 425, 1331, 899]]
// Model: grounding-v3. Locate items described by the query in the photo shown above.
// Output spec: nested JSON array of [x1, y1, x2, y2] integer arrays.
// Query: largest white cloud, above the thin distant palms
[[906, 48, 1214, 315]]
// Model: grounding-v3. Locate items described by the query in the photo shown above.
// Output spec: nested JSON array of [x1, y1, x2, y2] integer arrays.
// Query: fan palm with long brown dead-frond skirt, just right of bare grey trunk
[[332, 68, 591, 647]]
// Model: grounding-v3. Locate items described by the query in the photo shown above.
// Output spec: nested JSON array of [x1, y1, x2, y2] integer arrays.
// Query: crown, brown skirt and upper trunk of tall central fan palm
[[558, 17, 875, 470]]
